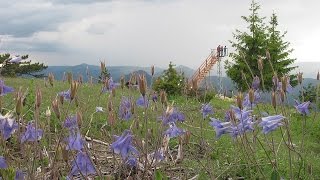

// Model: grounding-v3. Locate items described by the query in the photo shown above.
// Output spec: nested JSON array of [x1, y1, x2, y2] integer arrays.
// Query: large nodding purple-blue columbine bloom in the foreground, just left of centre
[[111, 130, 138, 160]]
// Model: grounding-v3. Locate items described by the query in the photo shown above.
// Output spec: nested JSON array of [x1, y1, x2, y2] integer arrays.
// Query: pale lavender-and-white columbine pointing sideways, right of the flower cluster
[[259, 115, 285, 134]]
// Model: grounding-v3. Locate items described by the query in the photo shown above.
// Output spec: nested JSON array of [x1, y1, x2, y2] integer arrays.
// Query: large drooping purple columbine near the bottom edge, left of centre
[[69, 151, 96, 176]]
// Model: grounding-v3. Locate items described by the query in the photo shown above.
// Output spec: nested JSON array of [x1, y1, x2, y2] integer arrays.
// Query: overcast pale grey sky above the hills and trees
[[0, 0, 320, 68]]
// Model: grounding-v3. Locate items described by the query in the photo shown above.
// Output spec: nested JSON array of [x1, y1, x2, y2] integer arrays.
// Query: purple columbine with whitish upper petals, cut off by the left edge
[[0, 113, 18, 140]]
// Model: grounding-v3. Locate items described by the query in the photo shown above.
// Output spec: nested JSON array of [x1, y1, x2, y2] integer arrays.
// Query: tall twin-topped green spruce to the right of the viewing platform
[[226, 1, 294, 91]]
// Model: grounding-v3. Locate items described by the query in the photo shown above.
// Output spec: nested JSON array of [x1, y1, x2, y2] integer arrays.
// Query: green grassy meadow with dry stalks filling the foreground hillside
[[0, 75, 320, 179]]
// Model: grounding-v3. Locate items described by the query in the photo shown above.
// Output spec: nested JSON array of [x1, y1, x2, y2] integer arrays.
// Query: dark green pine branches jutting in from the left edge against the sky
[[0, 54, 47, 78]]
